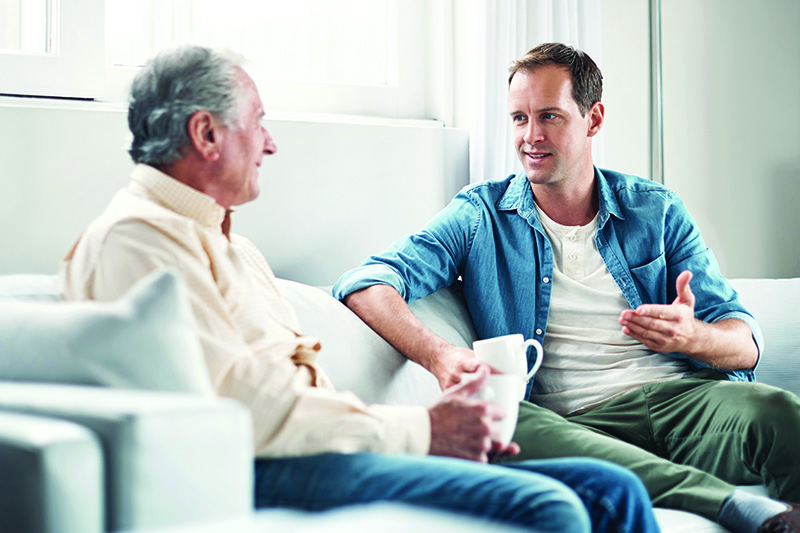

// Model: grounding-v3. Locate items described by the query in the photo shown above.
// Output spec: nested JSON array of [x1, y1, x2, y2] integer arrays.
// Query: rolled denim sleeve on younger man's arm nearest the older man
[[332, 187, 481, 302]]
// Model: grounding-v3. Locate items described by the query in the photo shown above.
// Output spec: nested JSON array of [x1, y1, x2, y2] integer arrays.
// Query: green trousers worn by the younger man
[[500, 370, 800, 521]]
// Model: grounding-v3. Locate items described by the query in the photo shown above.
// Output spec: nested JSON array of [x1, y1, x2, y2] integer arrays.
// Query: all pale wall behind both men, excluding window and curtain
[[0, 0, 800, 284]]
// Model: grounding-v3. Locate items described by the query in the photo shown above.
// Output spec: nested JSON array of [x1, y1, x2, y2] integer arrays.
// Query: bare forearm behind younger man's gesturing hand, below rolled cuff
[[684, 318, 758, 370]]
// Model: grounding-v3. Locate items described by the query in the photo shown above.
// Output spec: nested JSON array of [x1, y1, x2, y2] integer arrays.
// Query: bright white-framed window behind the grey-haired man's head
[[0, 0, 450, 118]]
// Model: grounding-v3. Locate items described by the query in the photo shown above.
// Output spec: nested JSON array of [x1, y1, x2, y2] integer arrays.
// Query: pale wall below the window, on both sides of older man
[[0, 98, 468, 285]]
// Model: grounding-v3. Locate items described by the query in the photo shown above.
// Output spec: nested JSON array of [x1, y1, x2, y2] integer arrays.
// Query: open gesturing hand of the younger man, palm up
[[619, 270, 699, 354]]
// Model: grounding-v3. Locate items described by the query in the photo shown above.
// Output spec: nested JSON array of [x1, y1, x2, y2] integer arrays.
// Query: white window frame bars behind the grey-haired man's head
[[0, 0, 452, 120]]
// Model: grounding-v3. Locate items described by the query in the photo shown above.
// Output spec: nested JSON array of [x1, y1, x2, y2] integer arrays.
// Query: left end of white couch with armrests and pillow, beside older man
[[0, 272, 253, 533]]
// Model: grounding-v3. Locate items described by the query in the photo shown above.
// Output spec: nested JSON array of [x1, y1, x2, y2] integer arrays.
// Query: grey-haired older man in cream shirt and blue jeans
[[61, 47, 657, 532]]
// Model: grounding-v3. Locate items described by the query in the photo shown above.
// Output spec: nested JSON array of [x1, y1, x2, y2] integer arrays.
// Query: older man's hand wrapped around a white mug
[[428, 369, 519, 463]]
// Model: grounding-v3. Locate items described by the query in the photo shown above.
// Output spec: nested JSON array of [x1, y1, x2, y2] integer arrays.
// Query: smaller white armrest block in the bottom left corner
[[0, 412, 104, 533]]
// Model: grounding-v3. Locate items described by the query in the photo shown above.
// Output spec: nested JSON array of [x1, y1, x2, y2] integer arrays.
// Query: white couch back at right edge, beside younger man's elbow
[[730, 278, 800, 395]]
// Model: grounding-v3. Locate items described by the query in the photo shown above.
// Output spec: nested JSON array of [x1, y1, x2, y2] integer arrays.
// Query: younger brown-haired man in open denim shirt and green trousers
[[334, 43, 800, 532]]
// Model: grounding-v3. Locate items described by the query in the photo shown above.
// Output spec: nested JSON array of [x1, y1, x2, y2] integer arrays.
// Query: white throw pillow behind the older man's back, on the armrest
[[0, 271, 213, 394]]
